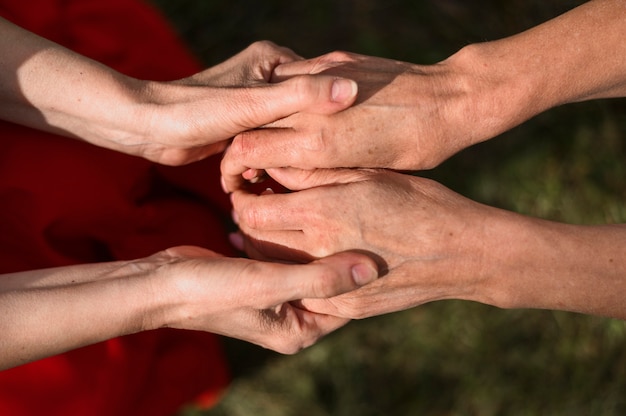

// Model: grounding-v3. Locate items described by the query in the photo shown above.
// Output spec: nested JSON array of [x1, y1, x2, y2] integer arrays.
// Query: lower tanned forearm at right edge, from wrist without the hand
[[475, 213, 626, 319]]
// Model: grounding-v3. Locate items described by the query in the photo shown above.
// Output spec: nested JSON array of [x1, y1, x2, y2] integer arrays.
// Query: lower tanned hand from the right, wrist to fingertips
[[227, 169, 493, 318]]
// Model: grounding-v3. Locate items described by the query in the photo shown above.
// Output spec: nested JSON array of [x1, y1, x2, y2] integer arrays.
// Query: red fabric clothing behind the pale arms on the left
[[0, 0, 232, 416]]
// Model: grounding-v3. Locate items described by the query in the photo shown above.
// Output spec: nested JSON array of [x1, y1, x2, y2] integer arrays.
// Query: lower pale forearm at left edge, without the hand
[[0, 261, 172, 369]]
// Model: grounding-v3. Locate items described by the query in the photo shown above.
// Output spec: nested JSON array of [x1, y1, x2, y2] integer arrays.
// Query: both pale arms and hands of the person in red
[[0, 19, 370, 369]]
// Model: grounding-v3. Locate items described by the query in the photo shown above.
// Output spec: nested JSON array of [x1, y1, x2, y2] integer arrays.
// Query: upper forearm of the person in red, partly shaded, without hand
[[0, 19, 155, 151]]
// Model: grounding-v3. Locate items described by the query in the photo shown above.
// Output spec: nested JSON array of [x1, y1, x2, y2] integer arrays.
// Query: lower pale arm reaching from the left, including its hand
[[0, 247, 377, 369]]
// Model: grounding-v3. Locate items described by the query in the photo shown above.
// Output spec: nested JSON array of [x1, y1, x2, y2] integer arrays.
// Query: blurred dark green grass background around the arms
[[147, 0, 626, 416]]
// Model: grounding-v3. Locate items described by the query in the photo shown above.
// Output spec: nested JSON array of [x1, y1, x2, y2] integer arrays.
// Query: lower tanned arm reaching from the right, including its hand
[[232, 170, 626, 319]]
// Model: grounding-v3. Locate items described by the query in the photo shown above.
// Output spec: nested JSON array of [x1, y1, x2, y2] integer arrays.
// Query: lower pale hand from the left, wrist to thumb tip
[[156, 247, 377, 353]]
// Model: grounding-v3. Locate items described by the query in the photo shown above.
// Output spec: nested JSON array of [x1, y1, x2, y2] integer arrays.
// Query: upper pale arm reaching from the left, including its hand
[[0, 18, 356, 165]]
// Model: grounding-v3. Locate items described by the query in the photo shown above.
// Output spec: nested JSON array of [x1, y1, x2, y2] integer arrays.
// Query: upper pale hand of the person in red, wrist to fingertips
[[124, 42, 356, 165]]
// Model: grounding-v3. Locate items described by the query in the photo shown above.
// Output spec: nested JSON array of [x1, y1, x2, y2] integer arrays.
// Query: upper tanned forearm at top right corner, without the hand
[[444, 0, 626, 144]]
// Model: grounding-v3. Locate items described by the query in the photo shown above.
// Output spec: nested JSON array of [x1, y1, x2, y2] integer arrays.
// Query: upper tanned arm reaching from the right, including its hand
[[222, 0, 626, 191]]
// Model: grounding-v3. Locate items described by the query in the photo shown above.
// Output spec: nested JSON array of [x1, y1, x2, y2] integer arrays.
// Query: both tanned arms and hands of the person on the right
[[222, 0, 626, 319]]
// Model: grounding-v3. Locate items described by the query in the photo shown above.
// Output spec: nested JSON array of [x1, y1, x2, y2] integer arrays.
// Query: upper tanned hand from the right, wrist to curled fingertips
[[222, 52, 476, 191]]
